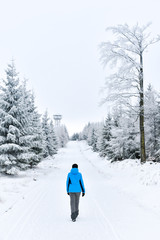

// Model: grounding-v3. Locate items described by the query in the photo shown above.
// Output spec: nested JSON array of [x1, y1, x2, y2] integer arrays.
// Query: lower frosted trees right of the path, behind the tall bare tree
[[79, 85, 160, 161]]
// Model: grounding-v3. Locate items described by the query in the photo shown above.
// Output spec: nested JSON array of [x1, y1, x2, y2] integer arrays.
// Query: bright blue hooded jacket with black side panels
[[66, 168, 85, 193]]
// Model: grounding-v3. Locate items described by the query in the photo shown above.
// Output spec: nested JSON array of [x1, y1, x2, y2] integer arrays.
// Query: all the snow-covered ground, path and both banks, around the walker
[[0, 142, 160, 240]]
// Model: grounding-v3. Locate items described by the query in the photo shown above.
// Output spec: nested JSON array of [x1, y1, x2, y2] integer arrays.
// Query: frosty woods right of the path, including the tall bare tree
[[80, 23, 160, 163]]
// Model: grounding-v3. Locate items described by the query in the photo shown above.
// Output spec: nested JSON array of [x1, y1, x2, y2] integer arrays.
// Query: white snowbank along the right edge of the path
[[80, 142, 160, 215]]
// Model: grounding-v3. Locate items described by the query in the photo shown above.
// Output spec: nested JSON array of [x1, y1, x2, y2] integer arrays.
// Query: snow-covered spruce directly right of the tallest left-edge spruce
[[18, 84, 43, 169]]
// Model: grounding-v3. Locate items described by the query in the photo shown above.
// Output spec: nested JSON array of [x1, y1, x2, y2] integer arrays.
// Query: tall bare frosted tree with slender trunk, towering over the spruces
[[100, 24, 160, 163]]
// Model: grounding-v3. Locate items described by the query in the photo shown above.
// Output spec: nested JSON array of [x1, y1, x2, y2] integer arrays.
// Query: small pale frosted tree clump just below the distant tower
[[55, 125, 69, 148]]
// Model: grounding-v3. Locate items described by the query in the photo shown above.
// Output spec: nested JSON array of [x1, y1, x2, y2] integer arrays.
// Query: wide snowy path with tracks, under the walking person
[[0, 142, 160, 240]]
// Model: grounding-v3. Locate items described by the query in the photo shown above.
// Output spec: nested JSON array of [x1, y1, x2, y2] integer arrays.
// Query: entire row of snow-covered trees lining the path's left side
[[0, 61, 68, 174]]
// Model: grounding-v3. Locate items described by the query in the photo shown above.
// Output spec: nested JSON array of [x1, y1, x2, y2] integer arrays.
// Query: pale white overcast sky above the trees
[[0, 0, 160, 134]]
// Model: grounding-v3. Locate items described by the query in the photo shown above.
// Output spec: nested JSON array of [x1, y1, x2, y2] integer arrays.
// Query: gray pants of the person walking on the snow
[[69, 192, 81, 220]]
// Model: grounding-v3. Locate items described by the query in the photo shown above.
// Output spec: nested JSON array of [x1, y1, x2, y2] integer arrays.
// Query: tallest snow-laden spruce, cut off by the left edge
[[0, 62, 24, 174]]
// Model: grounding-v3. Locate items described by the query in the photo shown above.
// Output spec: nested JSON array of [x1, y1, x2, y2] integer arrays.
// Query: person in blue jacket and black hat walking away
[[66, 163, 85, 222]]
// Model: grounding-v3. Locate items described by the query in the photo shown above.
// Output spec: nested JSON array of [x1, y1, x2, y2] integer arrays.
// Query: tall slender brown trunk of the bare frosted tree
[[139, 53, 146, 163]]
